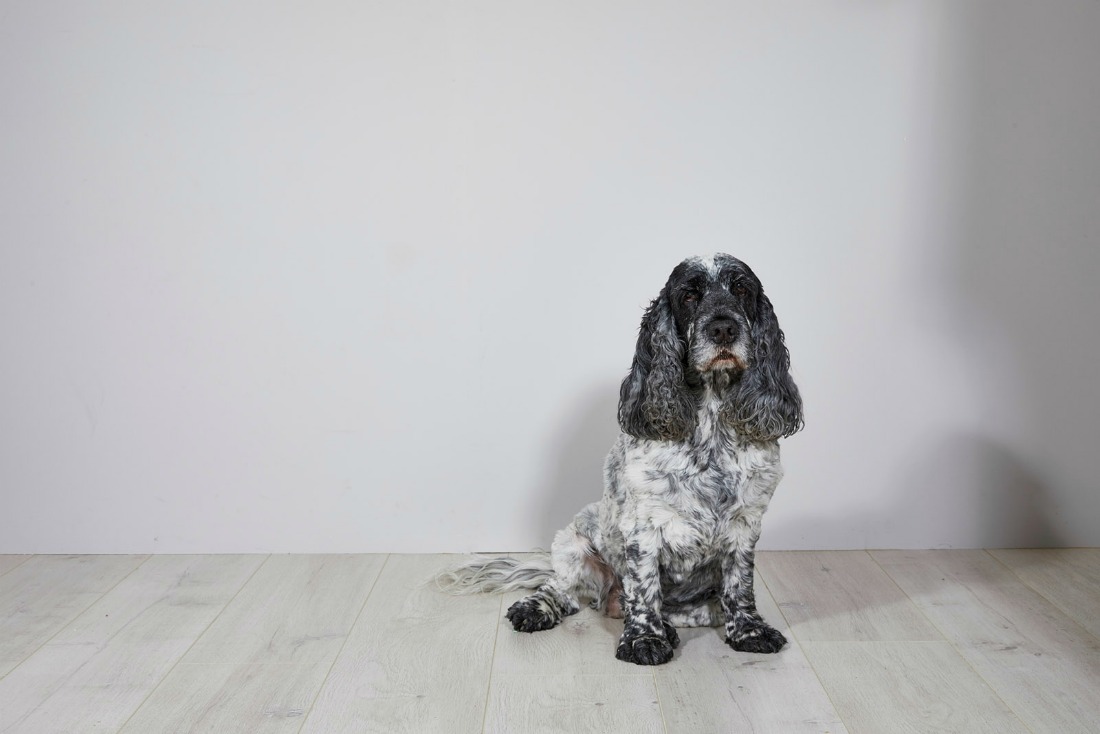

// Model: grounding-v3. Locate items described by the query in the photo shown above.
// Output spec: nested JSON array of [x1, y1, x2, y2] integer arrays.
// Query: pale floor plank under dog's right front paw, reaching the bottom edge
[[655, 578, 847, 734]]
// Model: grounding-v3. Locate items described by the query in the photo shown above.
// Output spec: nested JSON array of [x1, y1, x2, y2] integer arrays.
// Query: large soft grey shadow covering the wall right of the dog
[[778, 0, 1100, 548]]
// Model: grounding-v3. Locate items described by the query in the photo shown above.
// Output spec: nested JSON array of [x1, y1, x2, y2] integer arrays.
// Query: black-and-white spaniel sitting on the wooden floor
[[440, 253, 803, 665]]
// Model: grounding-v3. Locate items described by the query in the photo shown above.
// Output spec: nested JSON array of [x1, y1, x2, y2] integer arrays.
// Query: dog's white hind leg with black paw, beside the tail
[[506, 505, 612, 632]]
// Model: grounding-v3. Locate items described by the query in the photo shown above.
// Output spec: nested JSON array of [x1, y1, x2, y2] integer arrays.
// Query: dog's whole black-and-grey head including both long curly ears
[[619, 254, 802, 441]]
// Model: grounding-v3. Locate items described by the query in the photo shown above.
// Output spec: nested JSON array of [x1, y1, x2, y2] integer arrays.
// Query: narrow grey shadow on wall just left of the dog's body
[[531, 382, 619, 550]]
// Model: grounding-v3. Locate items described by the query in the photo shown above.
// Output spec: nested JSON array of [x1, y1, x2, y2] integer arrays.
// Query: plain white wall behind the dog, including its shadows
[[0, 0, 1100, 552]]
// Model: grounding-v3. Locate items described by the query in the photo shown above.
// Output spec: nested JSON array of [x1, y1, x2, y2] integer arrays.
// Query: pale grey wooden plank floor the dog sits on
[[0, 549, 1100, 734]]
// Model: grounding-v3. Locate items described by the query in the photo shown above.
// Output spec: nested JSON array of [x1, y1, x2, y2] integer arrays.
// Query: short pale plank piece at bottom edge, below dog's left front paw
[[484, 677, 664, 734]]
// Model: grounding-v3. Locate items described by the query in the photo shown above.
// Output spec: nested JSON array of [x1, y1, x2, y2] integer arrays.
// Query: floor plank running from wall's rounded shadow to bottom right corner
[[872, 550, 1100, 734]]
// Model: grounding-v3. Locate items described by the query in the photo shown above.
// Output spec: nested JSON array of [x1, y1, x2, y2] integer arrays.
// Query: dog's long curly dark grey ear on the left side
[[619, 286, 696, 441]]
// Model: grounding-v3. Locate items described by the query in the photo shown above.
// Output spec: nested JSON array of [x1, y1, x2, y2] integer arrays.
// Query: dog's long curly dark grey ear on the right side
[[722, 289, 803, 441]]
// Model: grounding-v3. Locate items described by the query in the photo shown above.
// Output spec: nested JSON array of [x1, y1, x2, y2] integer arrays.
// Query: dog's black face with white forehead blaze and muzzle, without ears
[[668, 254, 760, 376]]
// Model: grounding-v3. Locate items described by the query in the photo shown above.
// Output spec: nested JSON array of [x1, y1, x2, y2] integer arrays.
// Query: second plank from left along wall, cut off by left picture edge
[[0, 556, 146, 676]]
